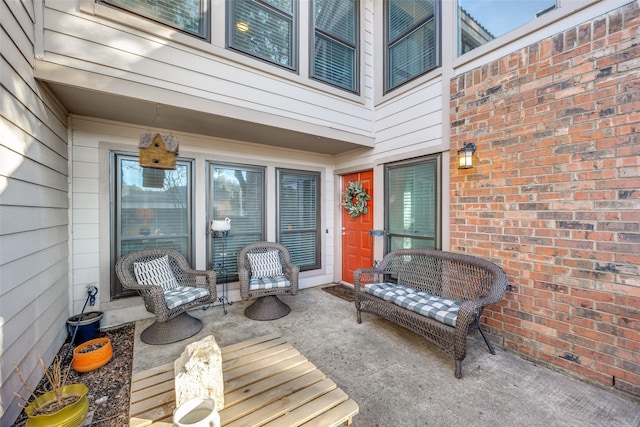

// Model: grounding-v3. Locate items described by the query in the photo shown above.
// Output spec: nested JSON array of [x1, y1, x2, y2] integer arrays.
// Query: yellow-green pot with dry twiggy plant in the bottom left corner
[[16, 356, 89, 427]]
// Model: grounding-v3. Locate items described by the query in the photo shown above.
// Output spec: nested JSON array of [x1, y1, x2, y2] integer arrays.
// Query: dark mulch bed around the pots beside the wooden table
[[15, 323, 135, 427]]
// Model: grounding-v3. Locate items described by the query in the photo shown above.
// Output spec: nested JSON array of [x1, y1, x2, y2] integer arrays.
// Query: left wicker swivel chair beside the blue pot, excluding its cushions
[[116, 248, 217, 344]]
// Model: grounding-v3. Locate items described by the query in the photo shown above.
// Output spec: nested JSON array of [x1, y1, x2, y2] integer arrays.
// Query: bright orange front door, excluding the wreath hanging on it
[[340, 170, 373, 283]]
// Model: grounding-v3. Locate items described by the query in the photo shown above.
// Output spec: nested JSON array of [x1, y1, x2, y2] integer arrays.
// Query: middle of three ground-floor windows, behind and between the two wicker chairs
[[207, 163, 265, 281]]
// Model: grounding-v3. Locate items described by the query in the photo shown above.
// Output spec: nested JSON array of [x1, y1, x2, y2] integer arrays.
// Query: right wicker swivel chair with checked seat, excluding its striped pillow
[[238, 242, 300, 320]]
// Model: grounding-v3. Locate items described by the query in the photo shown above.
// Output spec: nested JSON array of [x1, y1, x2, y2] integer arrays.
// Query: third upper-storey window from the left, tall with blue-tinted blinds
[[311, 0, 358, 92]]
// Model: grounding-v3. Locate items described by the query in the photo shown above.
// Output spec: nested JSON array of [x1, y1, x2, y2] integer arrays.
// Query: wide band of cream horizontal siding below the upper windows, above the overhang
[[44, 3, 371, 135]]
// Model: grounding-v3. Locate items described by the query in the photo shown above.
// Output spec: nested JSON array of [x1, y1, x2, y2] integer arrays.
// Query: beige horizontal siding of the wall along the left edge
[[0, 0, 69, 425]]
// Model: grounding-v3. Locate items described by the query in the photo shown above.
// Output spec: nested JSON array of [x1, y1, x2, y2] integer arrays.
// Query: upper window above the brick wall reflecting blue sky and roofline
[[458, 0, 556, 55]]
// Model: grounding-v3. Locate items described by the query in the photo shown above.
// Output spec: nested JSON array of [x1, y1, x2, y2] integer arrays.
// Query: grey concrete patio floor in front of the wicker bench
[[133, 287, 640, 427]]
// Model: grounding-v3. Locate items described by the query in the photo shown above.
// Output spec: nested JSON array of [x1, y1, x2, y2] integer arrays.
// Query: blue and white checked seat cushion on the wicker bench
[[364, 283, 461, 327]]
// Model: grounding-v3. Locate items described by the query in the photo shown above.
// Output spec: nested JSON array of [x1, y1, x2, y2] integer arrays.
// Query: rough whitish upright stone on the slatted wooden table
[[173, 335, 224, 411]]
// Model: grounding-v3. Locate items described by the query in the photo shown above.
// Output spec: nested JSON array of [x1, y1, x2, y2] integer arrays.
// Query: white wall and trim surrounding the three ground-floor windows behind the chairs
[[71, 117, 337, 326]]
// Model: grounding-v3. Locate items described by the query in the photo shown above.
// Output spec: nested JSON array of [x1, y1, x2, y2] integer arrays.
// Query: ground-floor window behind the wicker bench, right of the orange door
[[386, 157, 441, 251]]
